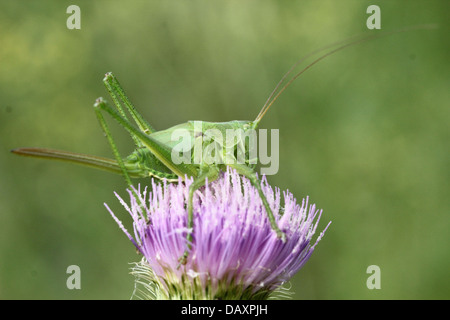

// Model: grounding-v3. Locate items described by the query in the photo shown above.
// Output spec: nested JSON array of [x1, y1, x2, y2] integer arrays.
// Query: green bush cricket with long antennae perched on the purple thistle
[[12, 27, 432, 263]]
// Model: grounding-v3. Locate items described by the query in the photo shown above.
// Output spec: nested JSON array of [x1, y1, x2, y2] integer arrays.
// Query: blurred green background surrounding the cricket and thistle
[[0, 0, 450, 299]]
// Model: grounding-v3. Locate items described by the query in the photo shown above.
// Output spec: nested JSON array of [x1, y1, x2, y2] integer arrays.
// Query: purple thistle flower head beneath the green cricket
[[105, 169, 329, 299]]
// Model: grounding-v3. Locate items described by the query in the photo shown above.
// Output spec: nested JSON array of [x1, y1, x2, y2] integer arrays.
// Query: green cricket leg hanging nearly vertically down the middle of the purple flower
[[178, 166, 220, 267]]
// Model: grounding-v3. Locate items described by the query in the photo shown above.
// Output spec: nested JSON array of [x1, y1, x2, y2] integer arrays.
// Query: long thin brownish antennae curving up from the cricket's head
[[254, 24, 437, 124]]
